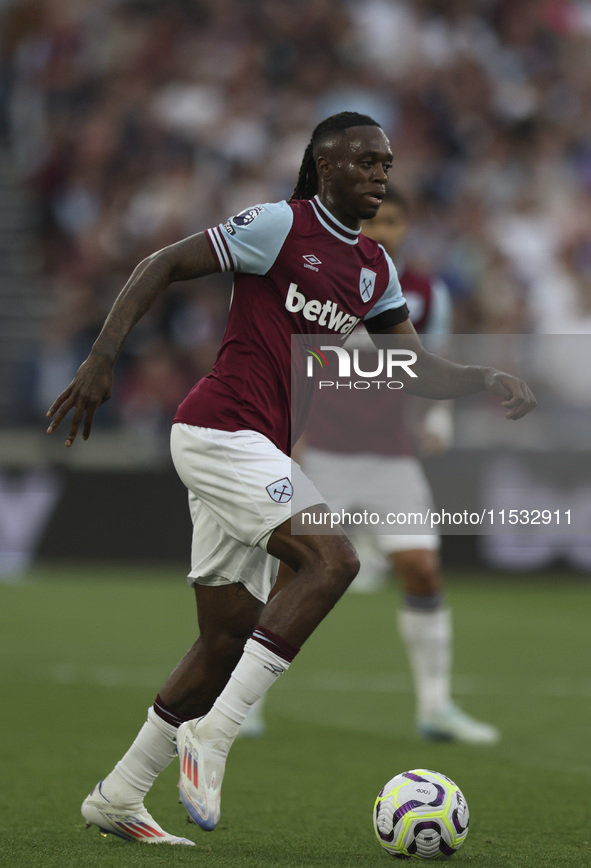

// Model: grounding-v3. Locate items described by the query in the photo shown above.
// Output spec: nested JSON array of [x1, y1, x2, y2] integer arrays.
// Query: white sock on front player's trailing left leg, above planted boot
[[101, 708, 177, 805]]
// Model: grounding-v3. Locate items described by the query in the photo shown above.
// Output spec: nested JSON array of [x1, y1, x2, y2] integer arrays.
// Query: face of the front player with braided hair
[[317, 127, 392, 229]]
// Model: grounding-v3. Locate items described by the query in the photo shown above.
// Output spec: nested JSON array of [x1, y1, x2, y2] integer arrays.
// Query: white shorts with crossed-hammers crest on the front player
[[170, 422, 323, 603]]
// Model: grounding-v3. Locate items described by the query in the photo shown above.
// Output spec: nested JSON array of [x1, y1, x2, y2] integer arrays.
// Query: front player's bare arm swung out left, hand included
[[47, 233, 218, 446]]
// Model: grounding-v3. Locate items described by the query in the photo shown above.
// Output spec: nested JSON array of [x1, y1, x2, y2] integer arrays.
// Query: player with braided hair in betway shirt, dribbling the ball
[[47, 112, 535, 845]]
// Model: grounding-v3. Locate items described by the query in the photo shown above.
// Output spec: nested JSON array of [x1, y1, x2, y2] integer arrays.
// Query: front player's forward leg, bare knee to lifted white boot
[[177, 509, 359, 831]]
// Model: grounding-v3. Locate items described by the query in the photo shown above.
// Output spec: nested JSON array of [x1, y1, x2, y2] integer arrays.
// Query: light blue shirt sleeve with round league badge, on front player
[[205, 202, 293, 274]]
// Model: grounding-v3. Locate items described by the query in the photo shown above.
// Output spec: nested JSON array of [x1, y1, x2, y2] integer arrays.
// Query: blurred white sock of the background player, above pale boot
[[398, 595, 452, 718]]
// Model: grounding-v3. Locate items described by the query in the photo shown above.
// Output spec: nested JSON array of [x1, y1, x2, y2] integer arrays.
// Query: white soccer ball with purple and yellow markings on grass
[[373, 769, 470, 859]]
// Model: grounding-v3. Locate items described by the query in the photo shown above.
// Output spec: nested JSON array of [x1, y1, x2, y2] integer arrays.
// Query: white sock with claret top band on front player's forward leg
[[200, 627, 299, 750]]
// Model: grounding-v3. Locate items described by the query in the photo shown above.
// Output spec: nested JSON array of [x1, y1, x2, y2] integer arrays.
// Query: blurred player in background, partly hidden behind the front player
[[242, 187, 499, 744]]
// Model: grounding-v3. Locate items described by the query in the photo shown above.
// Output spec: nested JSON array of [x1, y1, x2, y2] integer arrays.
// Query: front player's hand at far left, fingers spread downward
[[46, 355, 113, 447]]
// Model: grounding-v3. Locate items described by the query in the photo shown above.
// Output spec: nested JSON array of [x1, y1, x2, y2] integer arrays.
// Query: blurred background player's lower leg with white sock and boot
[[390, 549, 499, 744]]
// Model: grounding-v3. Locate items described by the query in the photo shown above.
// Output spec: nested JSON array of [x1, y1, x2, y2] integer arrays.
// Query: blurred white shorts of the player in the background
[[302, 448, 440, 555]]
